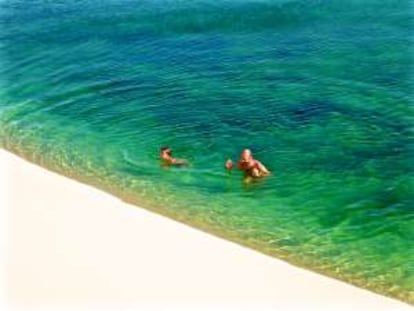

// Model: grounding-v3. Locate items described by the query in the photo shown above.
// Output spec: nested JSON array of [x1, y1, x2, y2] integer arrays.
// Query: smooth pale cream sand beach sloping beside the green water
[[0, 149, 413, 310]]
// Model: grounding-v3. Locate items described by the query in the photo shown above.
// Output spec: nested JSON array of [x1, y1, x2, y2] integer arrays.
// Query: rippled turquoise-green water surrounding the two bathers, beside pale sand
[[0, 0, 414, 303]]
